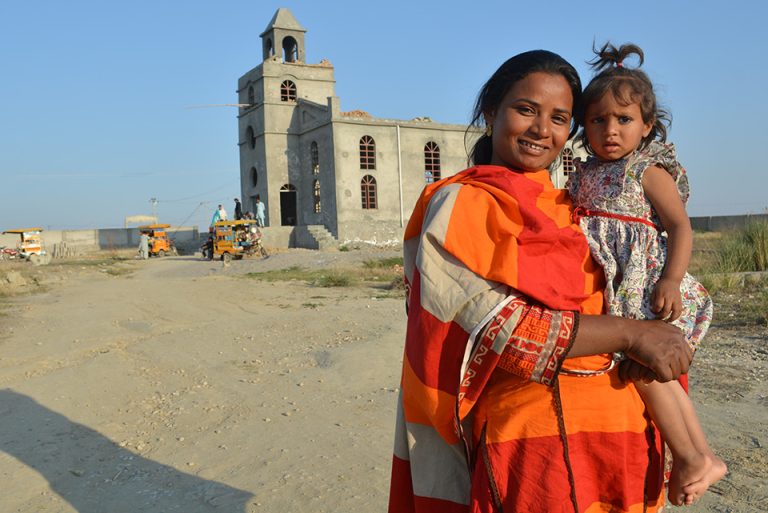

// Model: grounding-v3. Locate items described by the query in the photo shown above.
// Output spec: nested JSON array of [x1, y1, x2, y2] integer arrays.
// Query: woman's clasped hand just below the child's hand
[[619, 320, 693, 383]]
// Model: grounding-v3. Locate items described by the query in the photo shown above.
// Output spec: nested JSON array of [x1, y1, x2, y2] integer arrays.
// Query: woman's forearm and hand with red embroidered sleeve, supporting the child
[[454, 284, 692, 384]]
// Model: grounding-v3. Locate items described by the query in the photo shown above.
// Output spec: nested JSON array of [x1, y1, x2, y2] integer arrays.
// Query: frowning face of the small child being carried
[[584, 91, 653, 160]]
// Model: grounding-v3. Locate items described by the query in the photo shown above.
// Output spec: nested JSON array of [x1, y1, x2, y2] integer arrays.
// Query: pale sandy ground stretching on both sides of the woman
[[0, 250, 768, 513]]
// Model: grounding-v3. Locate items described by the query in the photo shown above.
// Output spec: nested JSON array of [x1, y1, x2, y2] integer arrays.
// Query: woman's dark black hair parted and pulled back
[[467, 50, 581, 165]]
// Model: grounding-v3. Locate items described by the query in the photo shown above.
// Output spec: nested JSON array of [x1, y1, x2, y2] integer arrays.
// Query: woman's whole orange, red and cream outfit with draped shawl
[[389, 166, 658, 513]]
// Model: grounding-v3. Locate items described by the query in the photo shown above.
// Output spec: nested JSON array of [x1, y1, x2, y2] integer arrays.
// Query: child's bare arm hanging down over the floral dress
[[642, 166, 693, 321]]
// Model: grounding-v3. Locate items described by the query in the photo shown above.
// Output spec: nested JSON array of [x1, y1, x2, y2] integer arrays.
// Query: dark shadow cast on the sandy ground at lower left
[[0, 390, 252, 513]]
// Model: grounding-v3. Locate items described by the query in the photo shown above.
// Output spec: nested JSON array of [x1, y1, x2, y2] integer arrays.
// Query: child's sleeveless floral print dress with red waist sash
[[568, 141, 712, 350]]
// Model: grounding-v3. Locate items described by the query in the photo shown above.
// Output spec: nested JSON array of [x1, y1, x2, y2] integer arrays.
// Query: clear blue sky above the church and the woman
[[0, 0, 768, 229]]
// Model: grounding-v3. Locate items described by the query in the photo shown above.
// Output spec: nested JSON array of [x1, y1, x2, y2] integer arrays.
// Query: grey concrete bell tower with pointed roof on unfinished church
[[237, 8, 336, 226]]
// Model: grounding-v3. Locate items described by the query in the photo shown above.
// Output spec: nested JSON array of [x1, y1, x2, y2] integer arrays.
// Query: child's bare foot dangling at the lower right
[[668, 452, 728, 506]]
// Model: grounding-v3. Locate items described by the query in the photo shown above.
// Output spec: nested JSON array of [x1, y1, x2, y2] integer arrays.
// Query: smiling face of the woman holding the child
[[485, 72, 573, 171]]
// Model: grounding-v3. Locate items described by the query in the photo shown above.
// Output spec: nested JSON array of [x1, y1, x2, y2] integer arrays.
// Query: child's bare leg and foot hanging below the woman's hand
[[637, 381, 727, 506]]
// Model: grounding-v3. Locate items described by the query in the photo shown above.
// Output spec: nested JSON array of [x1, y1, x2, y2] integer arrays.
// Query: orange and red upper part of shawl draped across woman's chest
[[404, 166, 603, 313]]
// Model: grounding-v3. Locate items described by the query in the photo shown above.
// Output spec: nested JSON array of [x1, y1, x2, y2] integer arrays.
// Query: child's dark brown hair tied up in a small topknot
[[576, 43, 672, 155]]
